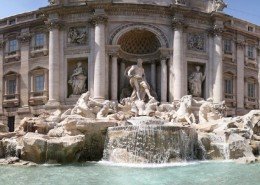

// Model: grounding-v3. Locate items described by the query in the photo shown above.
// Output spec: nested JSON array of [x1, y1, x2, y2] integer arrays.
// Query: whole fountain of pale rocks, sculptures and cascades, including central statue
[[0, 60, 260, 164]]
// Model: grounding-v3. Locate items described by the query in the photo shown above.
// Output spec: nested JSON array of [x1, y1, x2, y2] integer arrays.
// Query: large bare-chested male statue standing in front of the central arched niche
[[126, 59, 154, 101]]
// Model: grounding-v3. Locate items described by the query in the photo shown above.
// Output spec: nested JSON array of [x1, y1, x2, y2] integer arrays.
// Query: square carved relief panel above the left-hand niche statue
[[68, 27, 88, 45]]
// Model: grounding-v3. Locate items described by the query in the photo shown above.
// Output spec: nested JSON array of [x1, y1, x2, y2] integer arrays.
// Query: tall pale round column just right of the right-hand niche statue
[[209, 26, 223, 103]]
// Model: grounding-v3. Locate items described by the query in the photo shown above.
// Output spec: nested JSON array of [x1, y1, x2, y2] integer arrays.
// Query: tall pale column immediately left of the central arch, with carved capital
[[90, 10, 107, 100]]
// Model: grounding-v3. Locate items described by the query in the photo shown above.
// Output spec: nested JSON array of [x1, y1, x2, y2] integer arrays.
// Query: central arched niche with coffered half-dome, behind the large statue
[[107, 24, 169, 99]]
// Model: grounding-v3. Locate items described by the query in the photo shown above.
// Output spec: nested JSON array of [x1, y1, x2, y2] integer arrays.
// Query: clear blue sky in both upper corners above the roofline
[[0, 0, 260, 26]]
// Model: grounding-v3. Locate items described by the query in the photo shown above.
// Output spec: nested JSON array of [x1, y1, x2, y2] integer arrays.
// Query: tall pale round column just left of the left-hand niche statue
[[46, 19, 61, 106]]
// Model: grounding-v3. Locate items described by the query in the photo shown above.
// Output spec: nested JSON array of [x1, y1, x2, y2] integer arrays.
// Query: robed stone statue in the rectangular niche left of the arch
[[68, 62, 87, 95]]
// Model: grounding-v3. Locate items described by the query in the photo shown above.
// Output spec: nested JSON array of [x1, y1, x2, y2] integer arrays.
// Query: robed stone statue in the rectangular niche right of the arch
[[189, 66, 206, 97]]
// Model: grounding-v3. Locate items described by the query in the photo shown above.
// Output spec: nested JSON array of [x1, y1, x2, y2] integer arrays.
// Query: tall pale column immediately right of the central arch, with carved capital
[[172, 17, 187, 100]]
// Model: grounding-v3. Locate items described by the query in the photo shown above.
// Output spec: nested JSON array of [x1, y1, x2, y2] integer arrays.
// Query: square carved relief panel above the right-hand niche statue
[[187, 33, 205, 51]]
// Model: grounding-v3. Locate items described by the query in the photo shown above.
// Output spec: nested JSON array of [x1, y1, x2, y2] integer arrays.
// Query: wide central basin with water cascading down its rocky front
[[103, 117, 197, 163]]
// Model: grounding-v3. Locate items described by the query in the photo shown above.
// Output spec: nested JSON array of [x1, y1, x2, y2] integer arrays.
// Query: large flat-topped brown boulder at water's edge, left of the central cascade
[[21, 133, 85, 163]]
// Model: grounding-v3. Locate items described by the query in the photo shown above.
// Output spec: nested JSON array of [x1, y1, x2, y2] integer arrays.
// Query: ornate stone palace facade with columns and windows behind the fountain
[[0, 0, 260, 130]]
